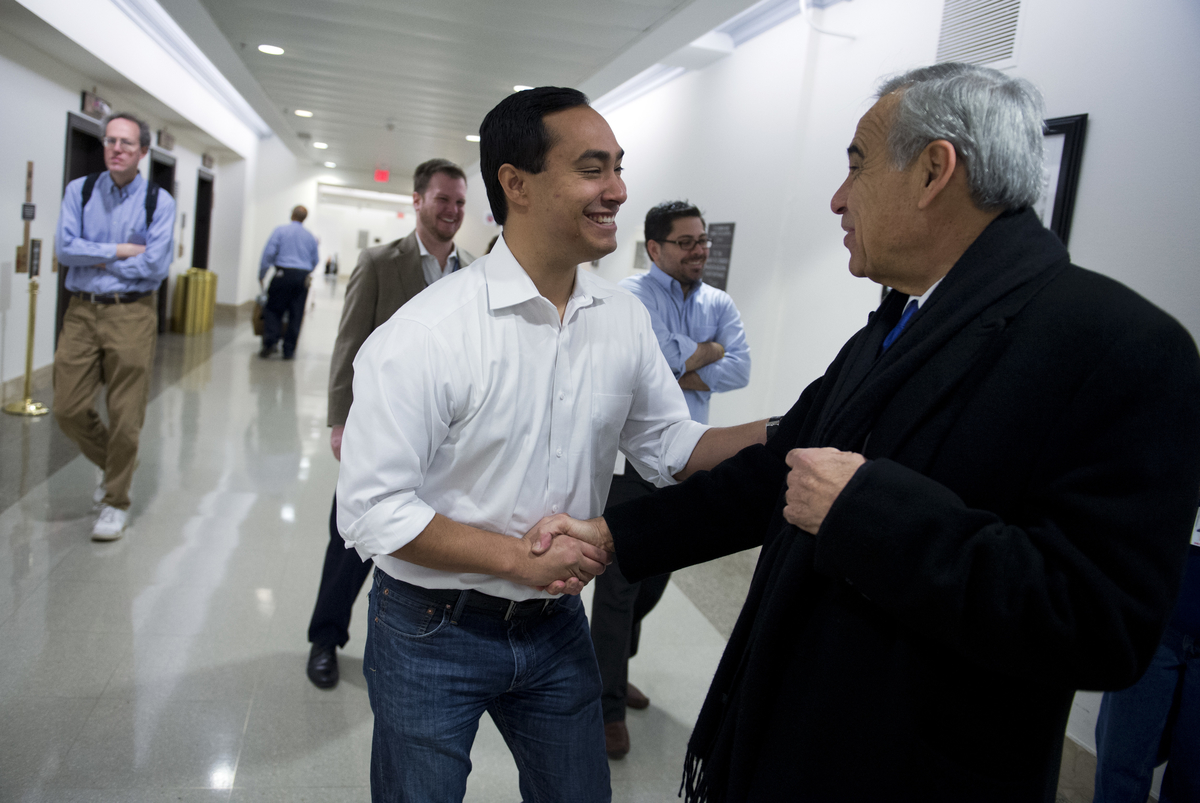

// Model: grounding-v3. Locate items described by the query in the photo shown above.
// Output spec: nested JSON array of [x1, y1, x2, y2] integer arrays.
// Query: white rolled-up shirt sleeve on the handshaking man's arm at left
[[337, 319, 455, 561]]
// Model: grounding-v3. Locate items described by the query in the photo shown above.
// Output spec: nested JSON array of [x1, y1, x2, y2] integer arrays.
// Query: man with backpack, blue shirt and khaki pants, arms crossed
[[54, 113, 175, 541]]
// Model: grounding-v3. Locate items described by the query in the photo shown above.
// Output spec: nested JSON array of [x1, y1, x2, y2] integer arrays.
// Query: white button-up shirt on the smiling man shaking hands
[[337, 236, 708, 600]]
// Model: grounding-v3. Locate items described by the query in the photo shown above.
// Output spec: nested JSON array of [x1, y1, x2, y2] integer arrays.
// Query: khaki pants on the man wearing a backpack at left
[[54, 295, 158, 510]]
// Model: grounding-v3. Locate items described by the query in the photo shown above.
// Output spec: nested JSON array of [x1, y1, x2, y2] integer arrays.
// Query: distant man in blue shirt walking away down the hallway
[[258, 206, 318, 360]]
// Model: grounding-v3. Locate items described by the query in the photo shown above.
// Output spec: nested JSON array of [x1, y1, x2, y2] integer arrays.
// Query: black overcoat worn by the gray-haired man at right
[[607, 210, 1200, 803]]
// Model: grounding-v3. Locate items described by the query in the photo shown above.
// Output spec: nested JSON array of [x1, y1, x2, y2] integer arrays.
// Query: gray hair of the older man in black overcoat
[[876, 62, 1044, 210]]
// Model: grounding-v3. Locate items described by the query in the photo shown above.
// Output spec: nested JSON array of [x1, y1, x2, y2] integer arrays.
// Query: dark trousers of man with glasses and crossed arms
[[592, 463, 671, 724]]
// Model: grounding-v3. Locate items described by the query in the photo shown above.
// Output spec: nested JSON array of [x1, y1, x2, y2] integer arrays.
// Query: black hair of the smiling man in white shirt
[[479, 86, 588, 226]]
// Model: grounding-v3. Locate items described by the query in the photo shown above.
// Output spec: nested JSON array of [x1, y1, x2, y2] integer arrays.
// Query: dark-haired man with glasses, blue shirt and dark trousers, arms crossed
[[592, 200, 750, 759]]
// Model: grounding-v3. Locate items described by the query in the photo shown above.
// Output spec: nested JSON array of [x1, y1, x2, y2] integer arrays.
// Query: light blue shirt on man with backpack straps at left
[[54, 170, 175, 294]]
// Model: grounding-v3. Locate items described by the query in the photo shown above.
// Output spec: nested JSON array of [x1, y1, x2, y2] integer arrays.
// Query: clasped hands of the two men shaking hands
[[515, 514, 613, 595]]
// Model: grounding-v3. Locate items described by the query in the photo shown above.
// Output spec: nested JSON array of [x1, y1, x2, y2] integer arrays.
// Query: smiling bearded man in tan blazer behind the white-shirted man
[[306, 158, 474, 689]]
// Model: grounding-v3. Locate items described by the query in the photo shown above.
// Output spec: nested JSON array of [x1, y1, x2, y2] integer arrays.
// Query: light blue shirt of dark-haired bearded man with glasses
[[620, 264, 750, 424]]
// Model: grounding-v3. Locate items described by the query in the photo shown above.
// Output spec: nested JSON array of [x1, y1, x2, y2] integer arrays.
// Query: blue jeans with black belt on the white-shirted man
[[362, 569, 612, 803]]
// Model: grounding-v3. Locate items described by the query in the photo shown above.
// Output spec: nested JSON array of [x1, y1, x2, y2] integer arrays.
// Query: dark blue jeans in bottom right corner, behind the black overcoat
[[1092, 629, 1200, 803]]
